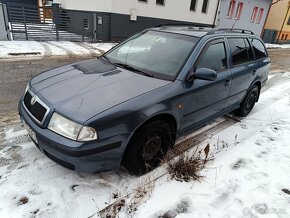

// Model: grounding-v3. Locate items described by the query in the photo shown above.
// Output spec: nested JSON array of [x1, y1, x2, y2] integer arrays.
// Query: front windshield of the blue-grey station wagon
[[104, 31, 198, 80]]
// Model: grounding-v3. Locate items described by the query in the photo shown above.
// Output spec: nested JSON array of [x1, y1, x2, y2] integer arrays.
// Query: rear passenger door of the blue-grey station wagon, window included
[[227, 37, 259, 105]]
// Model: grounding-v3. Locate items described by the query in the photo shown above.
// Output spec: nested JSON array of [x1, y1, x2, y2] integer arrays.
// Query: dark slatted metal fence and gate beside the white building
[[7, 3, 110, 42]]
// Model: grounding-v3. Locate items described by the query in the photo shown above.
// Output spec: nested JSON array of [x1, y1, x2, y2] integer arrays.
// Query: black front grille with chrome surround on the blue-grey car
[[23, 91, 49, 124]]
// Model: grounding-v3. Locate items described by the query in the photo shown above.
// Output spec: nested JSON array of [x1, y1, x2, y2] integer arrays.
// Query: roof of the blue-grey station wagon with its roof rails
[[149, 24, 256, 37]]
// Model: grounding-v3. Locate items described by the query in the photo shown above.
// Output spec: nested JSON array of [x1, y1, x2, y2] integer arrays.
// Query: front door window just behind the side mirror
[[195, 40, 227, 71]]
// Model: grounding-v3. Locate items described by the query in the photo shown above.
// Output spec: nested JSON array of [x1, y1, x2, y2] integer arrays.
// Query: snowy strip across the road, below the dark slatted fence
[[0, 41, 116, 60]]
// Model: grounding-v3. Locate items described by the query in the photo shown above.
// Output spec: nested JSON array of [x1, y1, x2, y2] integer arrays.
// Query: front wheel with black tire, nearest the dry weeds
[[123, 120, 174, 175]]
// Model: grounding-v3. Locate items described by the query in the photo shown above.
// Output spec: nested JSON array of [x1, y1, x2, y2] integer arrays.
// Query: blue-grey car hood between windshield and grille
[[30, 59, 171, 123]]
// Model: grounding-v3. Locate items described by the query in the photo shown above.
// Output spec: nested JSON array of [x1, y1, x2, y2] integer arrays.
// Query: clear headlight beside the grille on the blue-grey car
[[48, 113, 98, 141]]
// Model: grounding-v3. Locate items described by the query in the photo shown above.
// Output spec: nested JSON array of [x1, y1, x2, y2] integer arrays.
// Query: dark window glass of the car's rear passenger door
[[228, 38, 250, 66]]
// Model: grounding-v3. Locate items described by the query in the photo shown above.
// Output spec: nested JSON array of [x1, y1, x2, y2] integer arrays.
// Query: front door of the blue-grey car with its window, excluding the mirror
[[182, 39, 231, 130]]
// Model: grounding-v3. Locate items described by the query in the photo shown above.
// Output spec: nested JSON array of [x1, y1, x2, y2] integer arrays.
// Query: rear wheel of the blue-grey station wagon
[[234, 84, 260, 117]]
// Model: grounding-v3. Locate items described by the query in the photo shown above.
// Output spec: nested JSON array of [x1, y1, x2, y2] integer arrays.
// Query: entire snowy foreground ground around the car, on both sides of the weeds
[[0, 73, 290, 218]]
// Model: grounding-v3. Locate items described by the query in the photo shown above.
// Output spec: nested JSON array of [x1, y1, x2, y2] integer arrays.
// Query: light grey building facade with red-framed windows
[[216, 0, 272, 35]]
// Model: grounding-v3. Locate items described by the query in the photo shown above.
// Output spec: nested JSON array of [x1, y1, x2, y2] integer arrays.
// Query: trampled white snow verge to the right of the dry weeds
[[136, 74, 290, 218]]
